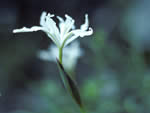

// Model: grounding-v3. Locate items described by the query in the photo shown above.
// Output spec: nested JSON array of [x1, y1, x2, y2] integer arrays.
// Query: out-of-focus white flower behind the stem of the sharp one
[[37, 41, 83, 70]]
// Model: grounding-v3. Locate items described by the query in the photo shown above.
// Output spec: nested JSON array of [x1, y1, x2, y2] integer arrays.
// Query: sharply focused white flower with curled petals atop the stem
[[13, 12, 93, 48]]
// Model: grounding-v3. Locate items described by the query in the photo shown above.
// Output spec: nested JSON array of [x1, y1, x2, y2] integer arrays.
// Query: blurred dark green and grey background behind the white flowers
[[0, 0, 150, 113]]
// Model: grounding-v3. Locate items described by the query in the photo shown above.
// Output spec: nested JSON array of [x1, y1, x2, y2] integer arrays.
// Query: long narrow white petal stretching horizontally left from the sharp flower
[[13, 26, 43, 33]]
